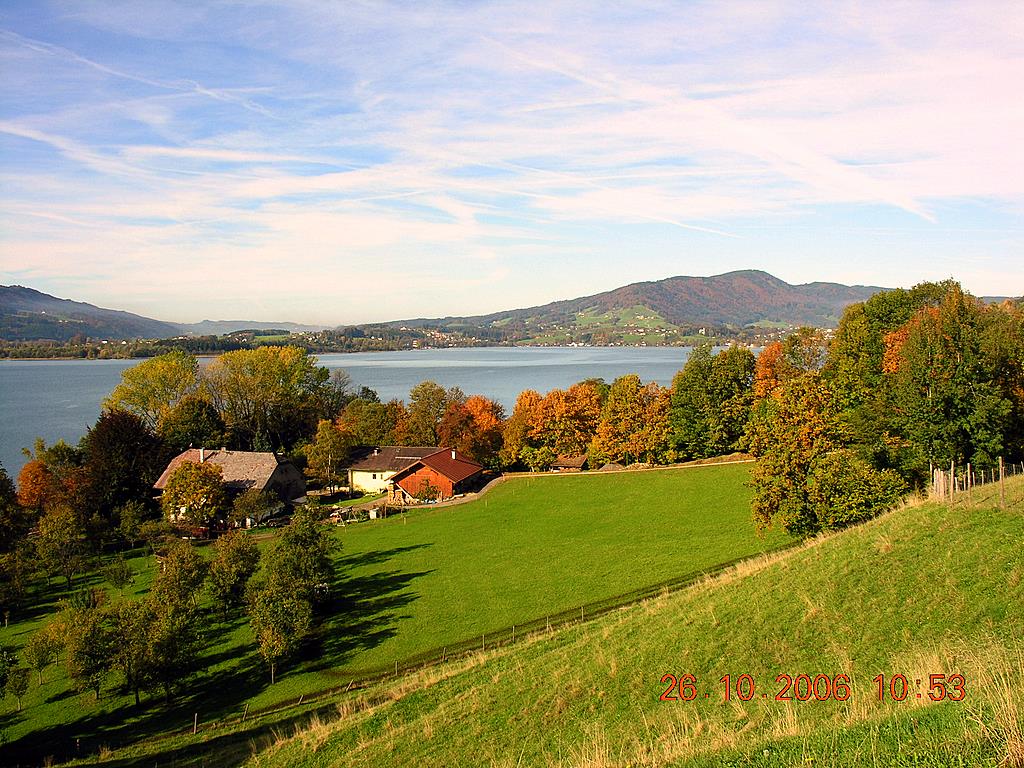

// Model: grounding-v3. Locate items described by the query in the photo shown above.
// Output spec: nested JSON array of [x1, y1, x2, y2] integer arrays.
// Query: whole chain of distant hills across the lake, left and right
[[0, 269, 1007, 343]]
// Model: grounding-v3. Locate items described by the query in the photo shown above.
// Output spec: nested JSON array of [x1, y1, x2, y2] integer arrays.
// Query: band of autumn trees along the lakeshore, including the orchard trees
[[0, 281, 1024, 716]]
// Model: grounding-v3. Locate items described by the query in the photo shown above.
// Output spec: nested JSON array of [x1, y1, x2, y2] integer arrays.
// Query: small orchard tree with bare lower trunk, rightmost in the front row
[[248, 580, 312, 685]]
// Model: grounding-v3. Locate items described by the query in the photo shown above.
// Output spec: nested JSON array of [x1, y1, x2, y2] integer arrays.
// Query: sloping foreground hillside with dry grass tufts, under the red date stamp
[[251, 479, 1024, 768]]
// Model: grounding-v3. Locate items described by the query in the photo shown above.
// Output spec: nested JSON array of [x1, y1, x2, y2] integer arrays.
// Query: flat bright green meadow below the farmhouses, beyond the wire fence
[[0, 465, 774, 763]]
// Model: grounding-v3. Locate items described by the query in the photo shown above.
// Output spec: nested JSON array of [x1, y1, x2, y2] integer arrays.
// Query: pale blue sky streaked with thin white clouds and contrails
[[0, 0, 1024, 324]]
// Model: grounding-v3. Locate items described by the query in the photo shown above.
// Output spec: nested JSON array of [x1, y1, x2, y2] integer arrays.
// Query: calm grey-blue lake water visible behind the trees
[[0, 347, 690, 477]]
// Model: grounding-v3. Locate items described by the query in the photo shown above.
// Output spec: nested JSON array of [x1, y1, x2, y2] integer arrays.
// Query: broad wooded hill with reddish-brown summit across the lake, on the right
[[385, 269, 885, 339]]
